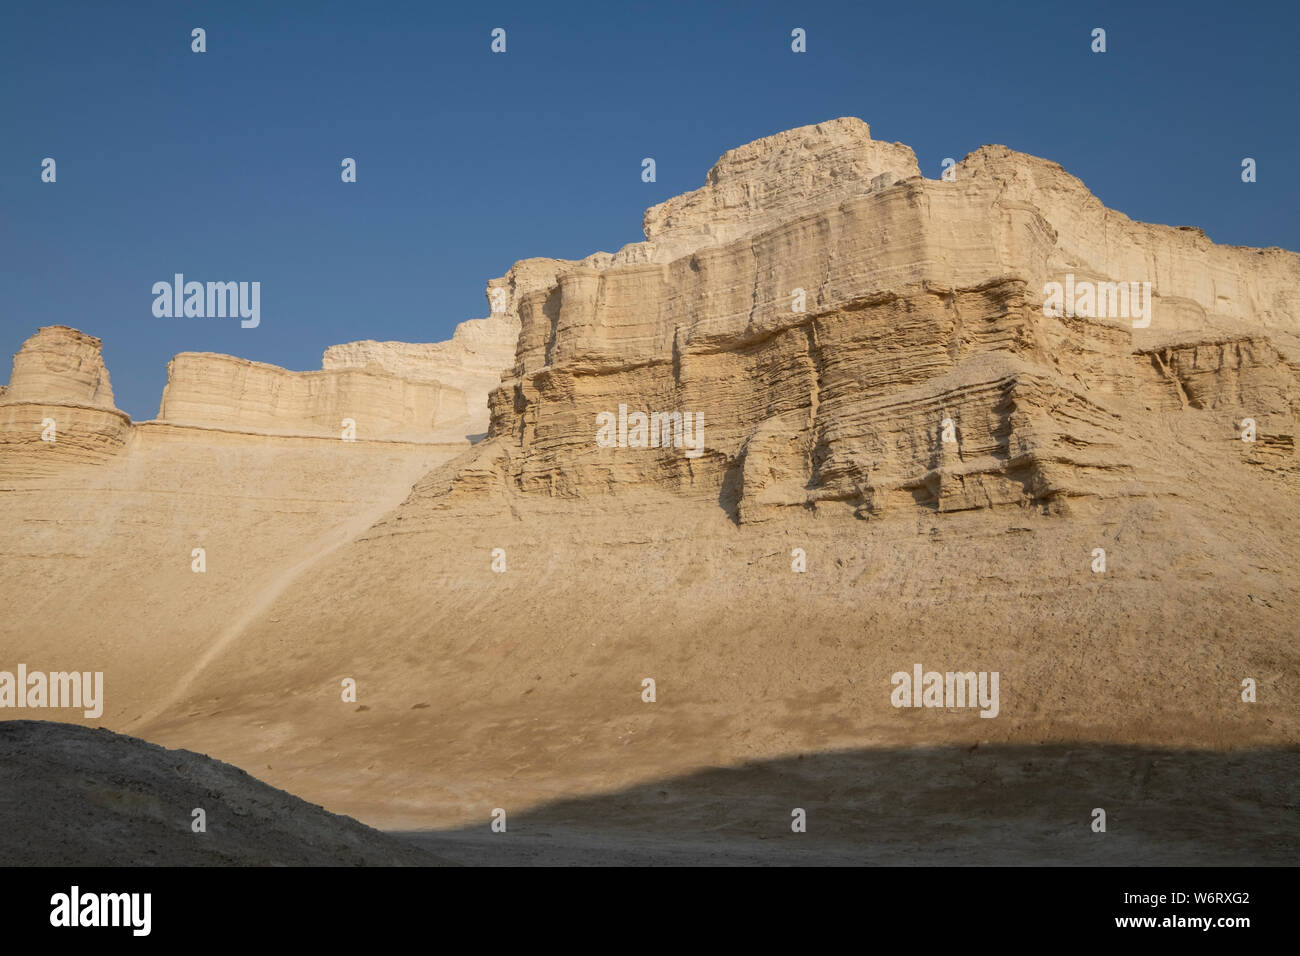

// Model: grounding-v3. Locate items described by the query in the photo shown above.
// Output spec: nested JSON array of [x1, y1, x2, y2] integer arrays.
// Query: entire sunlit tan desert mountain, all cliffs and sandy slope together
[[0, 120, 1300, 862]]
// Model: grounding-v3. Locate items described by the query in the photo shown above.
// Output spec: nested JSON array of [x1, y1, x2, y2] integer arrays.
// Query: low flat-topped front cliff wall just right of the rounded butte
[[159, 352, 468, 441]]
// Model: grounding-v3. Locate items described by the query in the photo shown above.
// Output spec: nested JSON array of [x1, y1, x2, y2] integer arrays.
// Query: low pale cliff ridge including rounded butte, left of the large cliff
[[0, 303, 519, 479]]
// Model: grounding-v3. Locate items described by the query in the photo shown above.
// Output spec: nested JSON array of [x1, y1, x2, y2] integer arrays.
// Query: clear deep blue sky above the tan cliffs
[[0, 0, 1300, 419]]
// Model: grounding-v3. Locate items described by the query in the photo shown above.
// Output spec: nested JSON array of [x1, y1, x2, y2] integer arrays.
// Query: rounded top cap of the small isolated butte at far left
[[0, 325, 116, 408]]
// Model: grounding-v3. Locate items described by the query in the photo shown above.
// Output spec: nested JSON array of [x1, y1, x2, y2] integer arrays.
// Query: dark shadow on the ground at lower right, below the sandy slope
[[403, 745, 1300, 866]]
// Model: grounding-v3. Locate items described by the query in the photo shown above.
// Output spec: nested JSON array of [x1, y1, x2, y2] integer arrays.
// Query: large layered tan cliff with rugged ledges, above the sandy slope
[[418, 120, 1300, 520]]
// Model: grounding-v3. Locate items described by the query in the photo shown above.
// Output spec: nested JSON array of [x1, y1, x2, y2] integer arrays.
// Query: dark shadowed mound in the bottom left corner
[[0, 721, 445, 866]]
